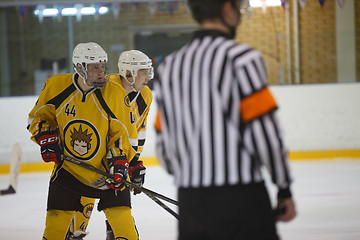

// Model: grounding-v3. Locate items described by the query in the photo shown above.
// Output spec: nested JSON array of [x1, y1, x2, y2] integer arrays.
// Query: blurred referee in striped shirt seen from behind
[[154, 0, 296, 240]]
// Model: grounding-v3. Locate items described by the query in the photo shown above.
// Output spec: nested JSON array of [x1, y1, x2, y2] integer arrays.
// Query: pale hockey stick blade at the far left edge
[[0, 143, 21, 195]]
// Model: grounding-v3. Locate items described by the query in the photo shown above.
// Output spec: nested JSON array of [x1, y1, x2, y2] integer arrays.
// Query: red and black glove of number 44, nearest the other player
[[105, 156, 129, 190]]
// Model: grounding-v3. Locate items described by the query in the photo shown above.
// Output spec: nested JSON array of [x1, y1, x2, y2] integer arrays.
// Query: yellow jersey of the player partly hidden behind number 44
[[110, 74, 153, 160]]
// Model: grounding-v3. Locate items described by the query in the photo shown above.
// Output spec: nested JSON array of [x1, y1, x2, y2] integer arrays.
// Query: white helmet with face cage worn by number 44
[[72, 42, 110, 88]]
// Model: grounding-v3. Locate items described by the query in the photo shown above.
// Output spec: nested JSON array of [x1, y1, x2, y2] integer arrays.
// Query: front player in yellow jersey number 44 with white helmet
[[28, 42, 138, 240]]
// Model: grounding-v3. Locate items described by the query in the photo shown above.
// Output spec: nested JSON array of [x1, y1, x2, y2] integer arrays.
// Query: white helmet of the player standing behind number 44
[[118, 50, 154, 81]]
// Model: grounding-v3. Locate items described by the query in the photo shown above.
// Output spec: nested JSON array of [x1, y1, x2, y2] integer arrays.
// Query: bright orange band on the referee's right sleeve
[[240, 87, 277, 122]]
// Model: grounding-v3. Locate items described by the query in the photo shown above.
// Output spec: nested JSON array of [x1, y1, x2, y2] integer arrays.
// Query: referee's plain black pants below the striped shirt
[[179, 183, 279, 240]]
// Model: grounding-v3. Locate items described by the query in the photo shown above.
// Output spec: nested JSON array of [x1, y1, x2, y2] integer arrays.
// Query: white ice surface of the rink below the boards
[[0, 159, 360, 240]]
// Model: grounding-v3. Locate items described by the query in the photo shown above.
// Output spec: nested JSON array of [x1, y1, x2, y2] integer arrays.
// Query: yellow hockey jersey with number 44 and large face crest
[[28, 74, 137, 189]]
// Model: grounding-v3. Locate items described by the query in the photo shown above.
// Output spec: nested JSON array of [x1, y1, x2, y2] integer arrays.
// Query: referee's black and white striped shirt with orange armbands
[[154, 30, 290, 195]]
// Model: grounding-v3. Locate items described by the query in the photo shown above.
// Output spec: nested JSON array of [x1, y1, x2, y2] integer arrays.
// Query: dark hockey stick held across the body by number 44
[[63, 155, 179, 206]]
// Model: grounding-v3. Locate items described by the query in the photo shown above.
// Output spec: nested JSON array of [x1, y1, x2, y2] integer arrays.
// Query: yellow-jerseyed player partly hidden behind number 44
[[67, 50, 154, 240]]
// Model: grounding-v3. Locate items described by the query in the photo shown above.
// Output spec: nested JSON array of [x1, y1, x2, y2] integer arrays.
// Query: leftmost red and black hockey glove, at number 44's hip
[[35, 130, 62, 165]]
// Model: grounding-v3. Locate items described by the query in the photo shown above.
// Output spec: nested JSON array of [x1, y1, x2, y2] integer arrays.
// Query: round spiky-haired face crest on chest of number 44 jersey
[[64, 120, 100, 160]]
